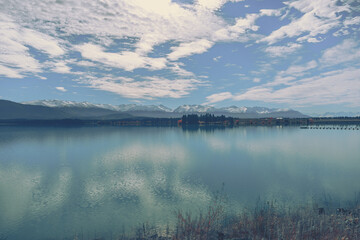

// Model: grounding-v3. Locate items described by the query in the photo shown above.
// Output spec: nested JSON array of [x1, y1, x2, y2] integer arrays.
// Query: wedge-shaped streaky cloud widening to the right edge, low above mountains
[[207, 36, 360, 107]]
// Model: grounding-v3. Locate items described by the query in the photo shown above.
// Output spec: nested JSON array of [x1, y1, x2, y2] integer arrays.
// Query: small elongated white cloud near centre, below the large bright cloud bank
[[168, 39, 214, 61]]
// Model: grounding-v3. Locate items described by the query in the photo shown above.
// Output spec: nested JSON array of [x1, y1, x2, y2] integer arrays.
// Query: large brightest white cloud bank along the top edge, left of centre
[[2, 0, 226, 55]]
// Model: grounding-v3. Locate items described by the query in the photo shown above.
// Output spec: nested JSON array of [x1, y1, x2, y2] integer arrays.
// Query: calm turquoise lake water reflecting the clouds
[[0, 127, 360, 240]]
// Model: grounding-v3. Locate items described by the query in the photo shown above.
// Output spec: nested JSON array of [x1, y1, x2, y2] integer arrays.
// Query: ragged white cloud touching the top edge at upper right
[[262, 0, 350, 44]]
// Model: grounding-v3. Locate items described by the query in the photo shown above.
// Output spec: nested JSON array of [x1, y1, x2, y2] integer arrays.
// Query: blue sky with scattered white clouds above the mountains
[[0, 0, 360, 113]]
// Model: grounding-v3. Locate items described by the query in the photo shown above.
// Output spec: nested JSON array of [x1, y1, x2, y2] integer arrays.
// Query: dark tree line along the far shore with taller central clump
[[0, 114, 360, 127]]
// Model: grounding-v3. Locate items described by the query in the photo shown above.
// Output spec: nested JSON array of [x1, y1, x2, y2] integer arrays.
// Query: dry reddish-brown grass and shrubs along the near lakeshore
[[75, 194, 360, 240]]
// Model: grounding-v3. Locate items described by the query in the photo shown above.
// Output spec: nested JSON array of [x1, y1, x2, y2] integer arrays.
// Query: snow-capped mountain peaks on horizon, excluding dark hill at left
[[23, 100, 306, 118]]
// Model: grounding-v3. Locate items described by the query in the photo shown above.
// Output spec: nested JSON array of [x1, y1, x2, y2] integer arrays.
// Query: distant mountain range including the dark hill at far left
[[0, 100, 308, 120]]
